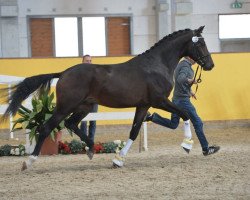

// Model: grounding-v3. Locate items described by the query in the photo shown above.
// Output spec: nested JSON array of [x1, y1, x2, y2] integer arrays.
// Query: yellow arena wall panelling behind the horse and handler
[[0, 53, 250, 128]]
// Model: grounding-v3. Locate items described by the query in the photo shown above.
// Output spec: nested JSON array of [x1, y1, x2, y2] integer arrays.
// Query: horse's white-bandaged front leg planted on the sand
[[113, 107, 149, 167]]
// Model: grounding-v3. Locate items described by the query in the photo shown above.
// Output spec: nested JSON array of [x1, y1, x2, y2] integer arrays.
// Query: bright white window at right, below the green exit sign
[[219, 14, 250, 39]]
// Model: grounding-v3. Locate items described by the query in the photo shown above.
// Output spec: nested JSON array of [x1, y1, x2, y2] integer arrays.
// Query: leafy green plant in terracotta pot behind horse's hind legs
[[12, 89, 65, 155]]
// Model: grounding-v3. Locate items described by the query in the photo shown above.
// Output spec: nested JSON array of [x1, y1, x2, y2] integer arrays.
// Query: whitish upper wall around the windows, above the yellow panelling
[[0, 0, 250, 57]]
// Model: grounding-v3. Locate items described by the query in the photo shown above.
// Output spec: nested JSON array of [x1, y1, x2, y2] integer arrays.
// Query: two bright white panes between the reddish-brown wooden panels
[[54, 17, 106, 57]]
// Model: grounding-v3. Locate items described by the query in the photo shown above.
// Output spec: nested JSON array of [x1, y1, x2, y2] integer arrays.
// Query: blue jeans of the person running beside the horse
[[152, 98, 208, 151]]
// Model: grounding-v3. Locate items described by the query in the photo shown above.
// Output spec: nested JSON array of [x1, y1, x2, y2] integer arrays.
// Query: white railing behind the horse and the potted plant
[[0, 75, 148, 151]]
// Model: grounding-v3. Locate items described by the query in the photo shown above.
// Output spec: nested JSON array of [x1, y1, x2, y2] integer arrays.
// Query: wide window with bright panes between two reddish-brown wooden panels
[[29, 17, 130, 57]]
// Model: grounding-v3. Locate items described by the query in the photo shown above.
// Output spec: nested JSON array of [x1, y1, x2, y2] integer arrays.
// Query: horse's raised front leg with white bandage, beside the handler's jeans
[[154, 98, 194, 153]]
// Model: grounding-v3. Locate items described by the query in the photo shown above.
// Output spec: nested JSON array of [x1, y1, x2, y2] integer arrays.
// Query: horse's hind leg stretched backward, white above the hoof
[[22, 110, 68, 171]]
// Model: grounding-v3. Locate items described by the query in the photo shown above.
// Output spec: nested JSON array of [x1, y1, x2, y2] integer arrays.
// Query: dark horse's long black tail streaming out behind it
[[1, 73, 61, 120]]
